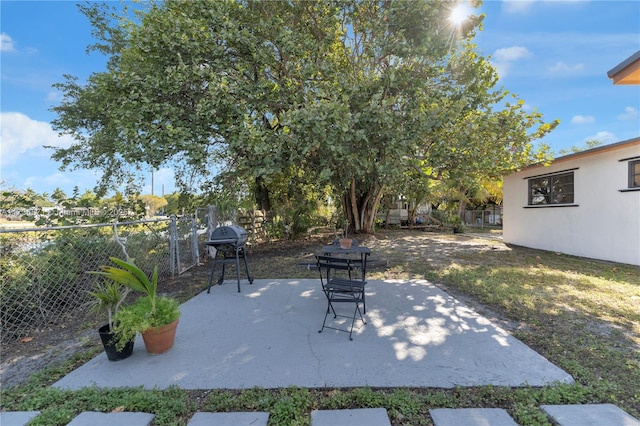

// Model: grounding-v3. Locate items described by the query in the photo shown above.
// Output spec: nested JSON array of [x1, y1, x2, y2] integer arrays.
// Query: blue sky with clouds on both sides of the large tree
[[0, 0, 640, 195]]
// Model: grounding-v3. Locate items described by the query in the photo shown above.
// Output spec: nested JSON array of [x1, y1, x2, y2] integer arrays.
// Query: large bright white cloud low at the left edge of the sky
[[0, 112, 74, 166]]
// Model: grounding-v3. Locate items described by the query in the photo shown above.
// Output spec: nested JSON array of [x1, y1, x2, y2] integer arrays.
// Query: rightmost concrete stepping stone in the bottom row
[[540, 404, 640, 426]]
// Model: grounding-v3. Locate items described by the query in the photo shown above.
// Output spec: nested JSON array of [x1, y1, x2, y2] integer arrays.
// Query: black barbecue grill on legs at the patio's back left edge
[[207, 225, 253, 293]]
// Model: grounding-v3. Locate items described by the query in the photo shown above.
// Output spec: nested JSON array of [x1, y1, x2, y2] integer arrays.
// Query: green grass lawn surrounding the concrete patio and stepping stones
[[0, 231, 640, 425]]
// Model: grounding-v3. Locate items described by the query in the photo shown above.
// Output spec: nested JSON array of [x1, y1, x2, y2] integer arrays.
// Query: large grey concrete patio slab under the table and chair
[[53, 279, 573, 389]]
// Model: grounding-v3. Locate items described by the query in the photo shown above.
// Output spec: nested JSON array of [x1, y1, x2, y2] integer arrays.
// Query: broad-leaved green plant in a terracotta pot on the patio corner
[[90, 257, 180, 355]]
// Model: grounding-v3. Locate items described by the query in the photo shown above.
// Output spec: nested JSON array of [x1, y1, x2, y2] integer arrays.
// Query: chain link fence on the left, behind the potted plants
[[0, 217, 199, 342]]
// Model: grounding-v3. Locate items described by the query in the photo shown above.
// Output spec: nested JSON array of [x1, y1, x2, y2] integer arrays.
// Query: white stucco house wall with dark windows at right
[[503, 138, 640, 265]]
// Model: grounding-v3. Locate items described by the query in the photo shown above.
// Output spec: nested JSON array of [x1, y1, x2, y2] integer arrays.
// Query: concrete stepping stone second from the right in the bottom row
[[429, 408, 518, 426]]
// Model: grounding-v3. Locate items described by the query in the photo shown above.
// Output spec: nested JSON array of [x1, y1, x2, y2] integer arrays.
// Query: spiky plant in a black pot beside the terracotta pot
[[88, 281, 135, 361]]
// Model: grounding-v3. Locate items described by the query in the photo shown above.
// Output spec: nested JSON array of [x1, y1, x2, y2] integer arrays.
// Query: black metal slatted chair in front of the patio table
[[316, 256, 367, 340]]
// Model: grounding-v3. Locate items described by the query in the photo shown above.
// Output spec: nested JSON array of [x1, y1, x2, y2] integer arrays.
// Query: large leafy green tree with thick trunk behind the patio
[[54, 0, 553, 232]]
